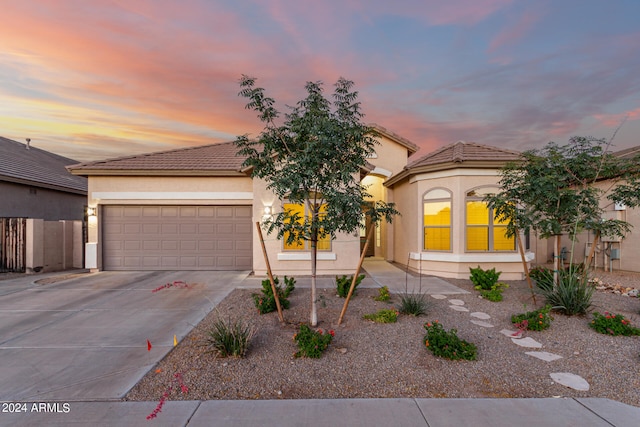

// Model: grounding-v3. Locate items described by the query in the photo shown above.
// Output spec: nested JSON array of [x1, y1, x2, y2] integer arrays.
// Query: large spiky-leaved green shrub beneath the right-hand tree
[[541, 268, 595, 316]]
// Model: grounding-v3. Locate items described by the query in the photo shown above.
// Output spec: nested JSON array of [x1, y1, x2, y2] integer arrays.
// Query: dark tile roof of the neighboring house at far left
[[0, 137, 87, 195]]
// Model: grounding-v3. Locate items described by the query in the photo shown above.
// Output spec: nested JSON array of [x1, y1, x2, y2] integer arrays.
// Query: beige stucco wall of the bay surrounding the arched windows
[[393, 168, 534, 280]]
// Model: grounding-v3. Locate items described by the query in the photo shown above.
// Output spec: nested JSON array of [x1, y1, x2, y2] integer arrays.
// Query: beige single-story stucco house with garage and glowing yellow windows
[[68, 125, 533, 280]]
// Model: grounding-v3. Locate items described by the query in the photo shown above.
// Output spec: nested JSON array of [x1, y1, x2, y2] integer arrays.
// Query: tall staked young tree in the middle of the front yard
[[235, 76, 397, 326]]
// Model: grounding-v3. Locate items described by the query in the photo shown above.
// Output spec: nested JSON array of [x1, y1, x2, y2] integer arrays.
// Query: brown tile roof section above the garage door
[[68, 142, 246, 176]]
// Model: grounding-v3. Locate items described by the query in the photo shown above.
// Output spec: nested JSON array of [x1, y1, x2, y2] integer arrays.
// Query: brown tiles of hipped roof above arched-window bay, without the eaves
[[405, 141, 520, 169]]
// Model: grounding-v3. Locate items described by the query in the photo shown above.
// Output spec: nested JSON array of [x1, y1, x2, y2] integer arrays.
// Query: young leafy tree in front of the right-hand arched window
[[486, 137, 640, 284]]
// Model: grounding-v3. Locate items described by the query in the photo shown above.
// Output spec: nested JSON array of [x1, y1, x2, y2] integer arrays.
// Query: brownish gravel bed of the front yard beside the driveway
[[126, 274, 640, 406]]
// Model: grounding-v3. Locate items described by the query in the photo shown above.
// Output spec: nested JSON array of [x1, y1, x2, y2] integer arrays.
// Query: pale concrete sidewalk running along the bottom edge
[[0, 398, 640, 427]]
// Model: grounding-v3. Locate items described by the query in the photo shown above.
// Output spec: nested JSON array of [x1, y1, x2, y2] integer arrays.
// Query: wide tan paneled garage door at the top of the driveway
[[102, 206, 253, 270]]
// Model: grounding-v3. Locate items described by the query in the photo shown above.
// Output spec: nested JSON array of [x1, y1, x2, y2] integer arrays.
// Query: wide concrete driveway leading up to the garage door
[[0, 271, 248, 402]]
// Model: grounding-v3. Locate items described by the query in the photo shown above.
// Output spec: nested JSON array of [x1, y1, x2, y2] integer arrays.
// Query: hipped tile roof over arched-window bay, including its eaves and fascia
[[385, 141, 521, 186]]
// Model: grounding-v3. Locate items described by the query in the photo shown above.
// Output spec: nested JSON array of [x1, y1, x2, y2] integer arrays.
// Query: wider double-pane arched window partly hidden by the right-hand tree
[[466, 187, 516, 252]]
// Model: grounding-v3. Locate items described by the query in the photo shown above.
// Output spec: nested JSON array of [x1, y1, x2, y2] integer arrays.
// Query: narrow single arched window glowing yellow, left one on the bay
[[422, 188, 451, 251]]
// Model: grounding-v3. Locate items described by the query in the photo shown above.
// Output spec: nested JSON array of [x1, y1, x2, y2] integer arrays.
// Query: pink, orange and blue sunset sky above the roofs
[[0, 0, 640, 161]]
